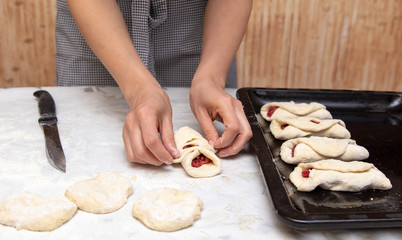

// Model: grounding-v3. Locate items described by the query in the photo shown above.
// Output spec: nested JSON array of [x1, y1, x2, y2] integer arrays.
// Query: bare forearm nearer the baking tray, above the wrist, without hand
[[193, 0, 252, 88]]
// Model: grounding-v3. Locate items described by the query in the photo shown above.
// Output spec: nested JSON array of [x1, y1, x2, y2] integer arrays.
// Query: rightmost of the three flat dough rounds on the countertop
[[132, 188, 203, 232]]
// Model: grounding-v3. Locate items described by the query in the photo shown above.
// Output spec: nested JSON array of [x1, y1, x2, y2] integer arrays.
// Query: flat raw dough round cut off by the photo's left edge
[[0, 192, 77, 231]]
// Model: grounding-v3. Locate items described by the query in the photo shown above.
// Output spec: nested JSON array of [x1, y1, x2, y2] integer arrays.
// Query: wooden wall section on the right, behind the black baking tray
[[238, 0, 402, 91]]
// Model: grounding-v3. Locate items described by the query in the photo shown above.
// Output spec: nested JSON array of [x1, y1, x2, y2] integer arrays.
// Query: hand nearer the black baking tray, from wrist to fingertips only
[[190, 79, 252, 157]]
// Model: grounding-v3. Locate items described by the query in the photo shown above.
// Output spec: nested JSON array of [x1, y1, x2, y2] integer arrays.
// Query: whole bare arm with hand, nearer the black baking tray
[[190, 0, 252, 157]]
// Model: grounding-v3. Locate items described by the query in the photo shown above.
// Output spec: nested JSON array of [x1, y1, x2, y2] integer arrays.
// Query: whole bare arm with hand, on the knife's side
[[67, 0, 179, 165]]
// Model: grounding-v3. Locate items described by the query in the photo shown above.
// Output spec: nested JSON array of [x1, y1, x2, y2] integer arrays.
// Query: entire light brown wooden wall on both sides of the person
[[0, 0, 402, 91]]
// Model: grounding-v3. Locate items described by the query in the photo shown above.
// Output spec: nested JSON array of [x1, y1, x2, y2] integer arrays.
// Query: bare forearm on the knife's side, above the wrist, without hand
[[67, 0, 157, 103]]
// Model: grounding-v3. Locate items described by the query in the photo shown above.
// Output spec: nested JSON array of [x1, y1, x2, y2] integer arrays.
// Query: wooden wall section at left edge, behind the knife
[[0, 0, 56, 88]]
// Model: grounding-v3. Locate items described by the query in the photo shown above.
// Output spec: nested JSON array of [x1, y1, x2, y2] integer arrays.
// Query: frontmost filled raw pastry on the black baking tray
[[289, 159, 392, 192]]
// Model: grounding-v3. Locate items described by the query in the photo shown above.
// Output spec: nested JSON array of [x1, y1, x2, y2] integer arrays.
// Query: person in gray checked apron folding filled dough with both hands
[[56, 0, 252, 165]]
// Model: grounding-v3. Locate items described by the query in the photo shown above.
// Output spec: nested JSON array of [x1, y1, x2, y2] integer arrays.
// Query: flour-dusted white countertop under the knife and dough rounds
[[0, 87, 402, 240]]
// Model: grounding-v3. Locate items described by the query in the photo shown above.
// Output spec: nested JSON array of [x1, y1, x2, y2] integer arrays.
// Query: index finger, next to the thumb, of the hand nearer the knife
[[140, 113, 173, 163]]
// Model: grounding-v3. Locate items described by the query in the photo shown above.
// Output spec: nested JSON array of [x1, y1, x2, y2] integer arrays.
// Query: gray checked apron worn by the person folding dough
[[56, 0, 237, 87]]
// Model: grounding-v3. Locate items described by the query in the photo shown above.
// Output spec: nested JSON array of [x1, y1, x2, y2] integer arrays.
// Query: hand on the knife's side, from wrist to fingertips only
[[123, 84, 180, 166]]
